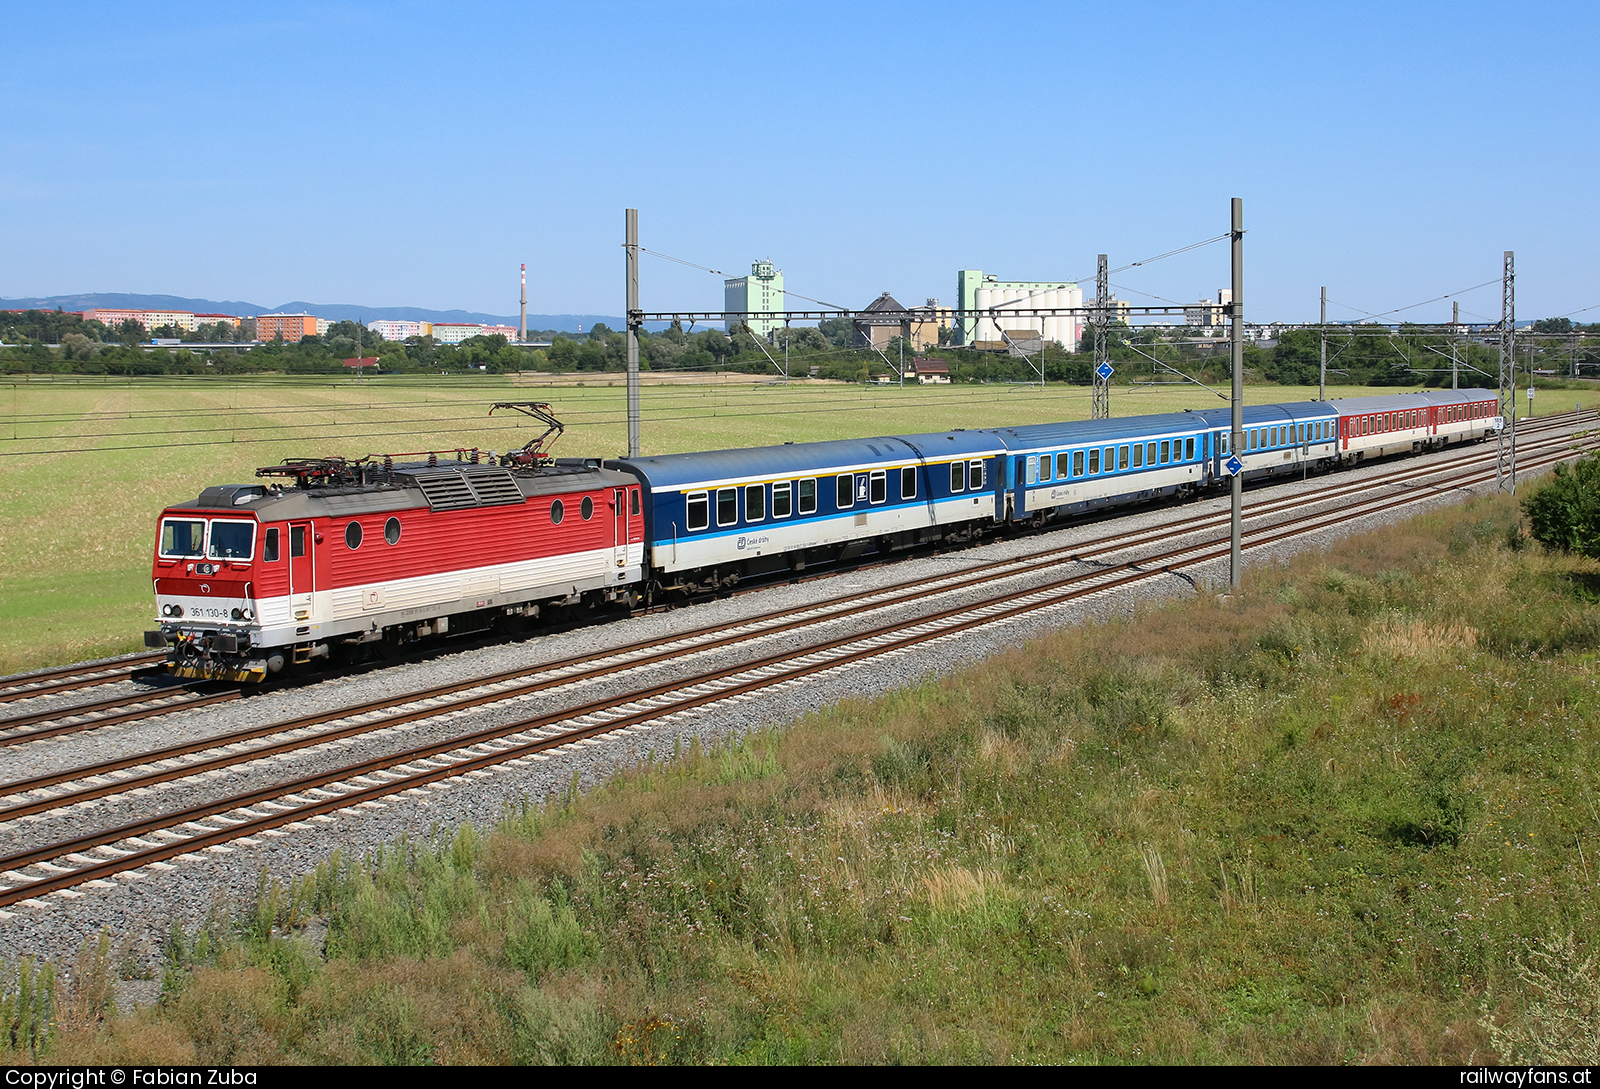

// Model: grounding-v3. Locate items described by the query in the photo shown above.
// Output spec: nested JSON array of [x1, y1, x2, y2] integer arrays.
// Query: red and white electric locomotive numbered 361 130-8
[[146, 405, 645, 681]]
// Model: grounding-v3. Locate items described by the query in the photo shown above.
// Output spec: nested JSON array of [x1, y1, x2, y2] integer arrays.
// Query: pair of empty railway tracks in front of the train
[[0, 415, 1570, 905]]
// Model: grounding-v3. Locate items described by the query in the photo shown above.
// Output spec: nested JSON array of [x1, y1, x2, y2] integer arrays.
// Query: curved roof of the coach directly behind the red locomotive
[[606, 432, 1005, 491]]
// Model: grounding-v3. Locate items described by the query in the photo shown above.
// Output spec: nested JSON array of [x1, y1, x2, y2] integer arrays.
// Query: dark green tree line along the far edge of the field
[[0, 310, 1600, 387]]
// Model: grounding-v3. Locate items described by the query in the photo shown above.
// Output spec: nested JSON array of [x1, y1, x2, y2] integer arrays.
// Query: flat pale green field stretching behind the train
[[0, 374, 1600, 673]]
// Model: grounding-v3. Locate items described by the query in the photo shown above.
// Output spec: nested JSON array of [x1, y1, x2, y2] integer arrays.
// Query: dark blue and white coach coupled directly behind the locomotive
[[606, 430, 1005, 590]]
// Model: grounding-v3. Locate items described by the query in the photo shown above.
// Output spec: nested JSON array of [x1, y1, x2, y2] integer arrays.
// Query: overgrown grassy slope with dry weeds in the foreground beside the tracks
[[21, 486, 1600, 1063]]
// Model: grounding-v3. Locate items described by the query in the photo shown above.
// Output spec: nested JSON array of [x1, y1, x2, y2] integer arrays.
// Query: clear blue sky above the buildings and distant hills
[[0, 0, 1600, 320]]
